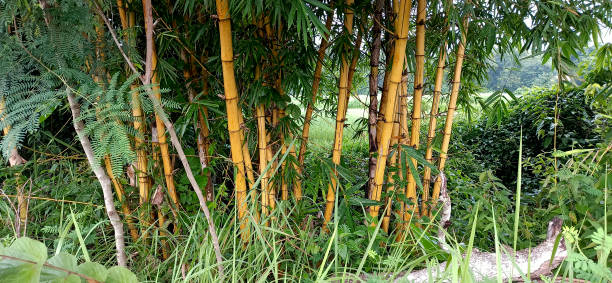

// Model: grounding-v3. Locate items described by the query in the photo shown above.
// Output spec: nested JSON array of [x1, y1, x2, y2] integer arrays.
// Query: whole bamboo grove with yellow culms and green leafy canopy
[[0, 0, 609, 273]]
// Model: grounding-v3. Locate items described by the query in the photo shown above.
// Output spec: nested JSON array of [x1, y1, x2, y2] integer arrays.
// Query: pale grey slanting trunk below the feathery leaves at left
[[66, 90, 127, 266]]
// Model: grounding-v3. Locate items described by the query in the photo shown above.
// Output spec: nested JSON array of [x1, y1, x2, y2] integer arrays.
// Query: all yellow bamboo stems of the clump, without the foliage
[[0, 0, 469, 268]]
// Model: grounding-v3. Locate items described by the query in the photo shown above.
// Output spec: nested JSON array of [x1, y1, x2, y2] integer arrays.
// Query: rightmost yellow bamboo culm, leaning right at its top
[[430, 18, 470, 209]]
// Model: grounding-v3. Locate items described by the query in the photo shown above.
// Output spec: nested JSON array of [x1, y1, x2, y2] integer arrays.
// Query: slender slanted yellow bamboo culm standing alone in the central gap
[[323, 0, 354, 231]]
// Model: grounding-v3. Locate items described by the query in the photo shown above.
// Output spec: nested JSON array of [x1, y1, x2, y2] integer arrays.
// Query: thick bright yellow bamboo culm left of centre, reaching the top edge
[[216, 0, 249, 242]]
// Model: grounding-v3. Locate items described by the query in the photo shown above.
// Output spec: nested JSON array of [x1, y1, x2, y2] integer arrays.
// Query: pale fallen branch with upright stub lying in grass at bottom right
[[360, 173, 567, 282]]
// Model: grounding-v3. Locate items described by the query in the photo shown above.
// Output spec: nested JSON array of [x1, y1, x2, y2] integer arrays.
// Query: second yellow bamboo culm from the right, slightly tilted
[[421, 42, 446, 219]]
